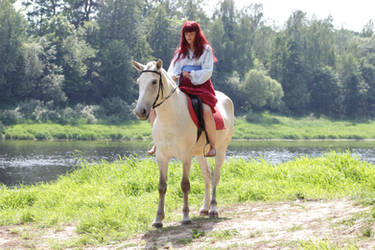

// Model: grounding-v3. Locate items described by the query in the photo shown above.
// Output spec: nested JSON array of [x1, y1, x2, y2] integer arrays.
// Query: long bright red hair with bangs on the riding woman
[[174, 21, 217, 62]]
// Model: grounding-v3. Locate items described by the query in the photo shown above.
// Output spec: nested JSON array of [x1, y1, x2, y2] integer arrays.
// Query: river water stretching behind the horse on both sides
[[0, 141, 375, 186]]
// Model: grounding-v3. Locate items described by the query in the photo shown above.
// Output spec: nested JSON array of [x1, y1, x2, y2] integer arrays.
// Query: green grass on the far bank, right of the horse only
[[233, 113, 375, 139]]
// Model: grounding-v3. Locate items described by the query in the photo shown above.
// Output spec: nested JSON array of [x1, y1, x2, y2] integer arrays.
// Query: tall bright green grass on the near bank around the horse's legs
[[0, 152, 375, 248]]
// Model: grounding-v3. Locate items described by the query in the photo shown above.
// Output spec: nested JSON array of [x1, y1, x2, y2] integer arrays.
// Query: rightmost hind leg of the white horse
[[208, 149, 226, 218]]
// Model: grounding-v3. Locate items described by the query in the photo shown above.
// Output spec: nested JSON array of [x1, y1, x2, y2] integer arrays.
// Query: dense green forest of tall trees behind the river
[[0, 0, 375, 125]]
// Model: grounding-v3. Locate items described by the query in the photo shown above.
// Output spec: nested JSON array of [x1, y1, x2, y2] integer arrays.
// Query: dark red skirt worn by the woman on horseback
[[180, 74, 217, 113]]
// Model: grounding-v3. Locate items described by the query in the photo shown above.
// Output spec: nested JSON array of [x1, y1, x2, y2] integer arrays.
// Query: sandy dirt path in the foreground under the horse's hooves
[[0, 200, 375, 249]]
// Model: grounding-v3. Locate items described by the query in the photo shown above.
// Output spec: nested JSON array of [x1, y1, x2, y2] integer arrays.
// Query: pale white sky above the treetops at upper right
[[208, 0, 375, 32]]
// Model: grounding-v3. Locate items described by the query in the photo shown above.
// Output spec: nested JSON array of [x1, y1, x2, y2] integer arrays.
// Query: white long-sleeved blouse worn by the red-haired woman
[[168, 44, 214, 85]]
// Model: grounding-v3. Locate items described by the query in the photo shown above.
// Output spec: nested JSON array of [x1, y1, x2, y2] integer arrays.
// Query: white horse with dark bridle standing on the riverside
[[132, 59, 234, 228]]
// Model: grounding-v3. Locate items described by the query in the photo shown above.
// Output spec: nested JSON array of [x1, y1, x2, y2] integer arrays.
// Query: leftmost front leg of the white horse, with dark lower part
[[152, 159, 168, 228]]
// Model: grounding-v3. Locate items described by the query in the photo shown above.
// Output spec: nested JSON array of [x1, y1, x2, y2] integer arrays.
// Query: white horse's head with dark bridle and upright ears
[[132, 59, 163, 120]]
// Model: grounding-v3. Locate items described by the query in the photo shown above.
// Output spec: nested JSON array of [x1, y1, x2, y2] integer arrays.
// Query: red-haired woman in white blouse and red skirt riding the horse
[[148, 21, 217, 157]]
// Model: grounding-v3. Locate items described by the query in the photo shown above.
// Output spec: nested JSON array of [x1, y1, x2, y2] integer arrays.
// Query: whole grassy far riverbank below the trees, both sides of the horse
[[1, 113, 375, 141]]
